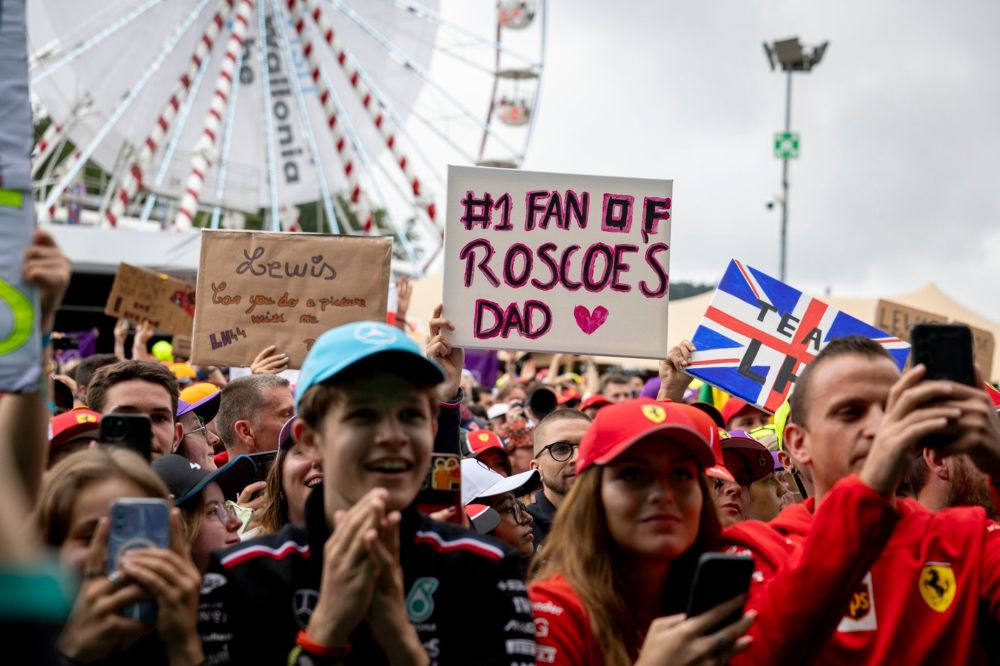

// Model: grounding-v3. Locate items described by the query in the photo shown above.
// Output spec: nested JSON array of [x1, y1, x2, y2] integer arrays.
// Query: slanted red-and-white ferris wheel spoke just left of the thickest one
[[104, 0, 234, 227]]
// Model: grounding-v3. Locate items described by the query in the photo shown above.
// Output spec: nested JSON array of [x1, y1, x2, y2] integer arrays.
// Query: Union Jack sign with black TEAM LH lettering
[[687, 259, 910, 413]]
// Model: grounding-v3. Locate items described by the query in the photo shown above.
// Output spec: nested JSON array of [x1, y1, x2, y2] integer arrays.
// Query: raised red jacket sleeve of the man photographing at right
[[725, 476, 899, 664]]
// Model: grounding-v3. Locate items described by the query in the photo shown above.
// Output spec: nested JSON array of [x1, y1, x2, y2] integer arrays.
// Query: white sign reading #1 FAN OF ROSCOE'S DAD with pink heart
[[442, 166, 672, 358]]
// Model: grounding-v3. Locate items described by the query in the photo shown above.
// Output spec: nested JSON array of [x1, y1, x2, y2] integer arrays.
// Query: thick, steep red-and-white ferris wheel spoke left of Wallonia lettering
[[174, 0, 253, 229]]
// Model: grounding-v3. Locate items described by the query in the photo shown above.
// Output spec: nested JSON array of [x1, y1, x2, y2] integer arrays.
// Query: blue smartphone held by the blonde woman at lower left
[[108, 497, 170, 624]]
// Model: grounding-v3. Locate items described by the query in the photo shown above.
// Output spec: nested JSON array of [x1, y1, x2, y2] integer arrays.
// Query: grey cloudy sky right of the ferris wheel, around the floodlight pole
[[524, 0, 1000, 321]]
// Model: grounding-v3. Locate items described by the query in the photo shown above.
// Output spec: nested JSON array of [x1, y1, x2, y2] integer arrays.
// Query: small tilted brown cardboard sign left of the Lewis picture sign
[[104, 263, 195, 335]]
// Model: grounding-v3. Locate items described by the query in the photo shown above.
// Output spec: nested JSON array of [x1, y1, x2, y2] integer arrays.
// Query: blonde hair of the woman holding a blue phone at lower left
[[34, 446, 170, 548]]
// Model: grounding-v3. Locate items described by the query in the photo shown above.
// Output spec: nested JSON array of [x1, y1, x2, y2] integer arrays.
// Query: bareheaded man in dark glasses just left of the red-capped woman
[[527, 409, 590, 548]]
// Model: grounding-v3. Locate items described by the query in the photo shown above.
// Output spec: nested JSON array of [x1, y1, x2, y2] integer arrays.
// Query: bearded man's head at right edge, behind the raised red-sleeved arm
[[900, 448, 1000, 520]]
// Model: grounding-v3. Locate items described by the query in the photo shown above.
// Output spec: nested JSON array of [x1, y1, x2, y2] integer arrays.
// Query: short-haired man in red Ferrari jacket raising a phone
[[726, 337, 1000, 666]]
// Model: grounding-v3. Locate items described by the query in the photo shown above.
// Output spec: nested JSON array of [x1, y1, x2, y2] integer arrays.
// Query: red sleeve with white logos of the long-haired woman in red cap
[[528, 578, 602, 666]]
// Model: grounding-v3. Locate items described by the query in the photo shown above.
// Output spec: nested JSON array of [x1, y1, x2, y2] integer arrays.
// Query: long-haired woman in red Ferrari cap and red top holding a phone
[[528, 398, 754, 666]]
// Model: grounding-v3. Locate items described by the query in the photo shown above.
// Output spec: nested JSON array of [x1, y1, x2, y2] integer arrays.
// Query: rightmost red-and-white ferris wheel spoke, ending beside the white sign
[[298, 0, 438, 225]]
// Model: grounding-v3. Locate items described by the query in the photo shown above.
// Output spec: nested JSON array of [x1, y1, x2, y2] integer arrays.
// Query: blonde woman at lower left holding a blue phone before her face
[[34, 447, 204, 666]]
